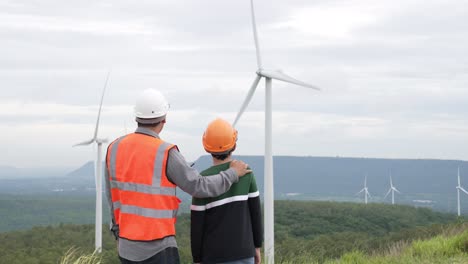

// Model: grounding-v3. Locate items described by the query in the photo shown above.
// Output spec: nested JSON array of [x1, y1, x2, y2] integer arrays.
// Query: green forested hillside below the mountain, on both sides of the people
[[0, 201, 463, 264]]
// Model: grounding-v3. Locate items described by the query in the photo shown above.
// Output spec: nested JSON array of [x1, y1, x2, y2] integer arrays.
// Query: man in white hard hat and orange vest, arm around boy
[[106, 89, 250, 263]]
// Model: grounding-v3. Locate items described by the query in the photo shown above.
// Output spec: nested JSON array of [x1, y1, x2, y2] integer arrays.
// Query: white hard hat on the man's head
[[135, 89, 169, 124]]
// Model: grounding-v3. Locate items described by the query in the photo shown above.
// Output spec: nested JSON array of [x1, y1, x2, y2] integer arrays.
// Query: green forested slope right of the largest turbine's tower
[[275, 201, 456, 262]]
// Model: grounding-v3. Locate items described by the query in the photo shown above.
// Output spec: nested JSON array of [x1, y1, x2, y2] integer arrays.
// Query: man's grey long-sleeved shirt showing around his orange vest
[[105, 127, 239, 261]]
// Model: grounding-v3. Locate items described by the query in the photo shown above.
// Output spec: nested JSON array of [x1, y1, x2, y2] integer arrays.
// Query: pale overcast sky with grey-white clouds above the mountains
[[0, 0, 468, 168]]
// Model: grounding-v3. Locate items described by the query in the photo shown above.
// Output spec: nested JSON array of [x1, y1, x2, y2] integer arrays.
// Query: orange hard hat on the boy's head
[[203, 118, 237, 154]]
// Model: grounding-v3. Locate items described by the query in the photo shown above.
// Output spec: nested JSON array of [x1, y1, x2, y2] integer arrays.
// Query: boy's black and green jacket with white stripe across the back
[[190, 162, 263, 264]]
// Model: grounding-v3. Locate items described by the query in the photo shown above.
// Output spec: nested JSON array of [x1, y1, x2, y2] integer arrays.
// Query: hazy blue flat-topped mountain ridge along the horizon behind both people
[[0, 156, 468, 212]]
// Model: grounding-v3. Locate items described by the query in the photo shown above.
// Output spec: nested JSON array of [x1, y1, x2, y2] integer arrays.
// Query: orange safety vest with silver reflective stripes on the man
[[106, 133, 180, 241]]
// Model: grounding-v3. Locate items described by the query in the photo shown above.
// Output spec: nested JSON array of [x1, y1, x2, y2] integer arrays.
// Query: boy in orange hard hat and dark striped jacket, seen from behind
[[190, 119, 262, 264]]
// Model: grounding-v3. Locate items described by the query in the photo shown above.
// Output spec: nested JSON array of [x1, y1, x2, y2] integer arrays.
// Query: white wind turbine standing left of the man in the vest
[[73, 71, 110, 253]]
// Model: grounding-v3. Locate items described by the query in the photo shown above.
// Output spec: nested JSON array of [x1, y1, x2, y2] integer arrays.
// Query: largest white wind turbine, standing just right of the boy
[[233, 0, 320, 264]]
